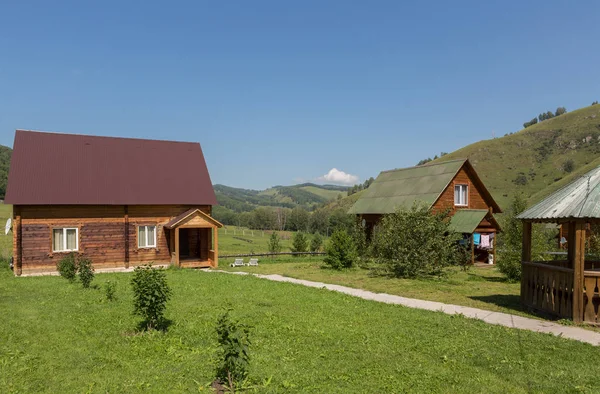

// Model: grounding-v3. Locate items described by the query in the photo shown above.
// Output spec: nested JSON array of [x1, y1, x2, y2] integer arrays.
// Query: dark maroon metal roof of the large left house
[[5, 130, 217, 205]]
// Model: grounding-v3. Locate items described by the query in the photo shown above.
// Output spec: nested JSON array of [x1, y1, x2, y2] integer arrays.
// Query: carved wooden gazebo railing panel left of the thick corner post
[[521, 261, 573, 318]]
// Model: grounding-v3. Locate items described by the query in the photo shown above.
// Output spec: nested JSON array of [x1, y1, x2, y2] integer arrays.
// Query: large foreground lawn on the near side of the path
[[0, 262, 600, 393]]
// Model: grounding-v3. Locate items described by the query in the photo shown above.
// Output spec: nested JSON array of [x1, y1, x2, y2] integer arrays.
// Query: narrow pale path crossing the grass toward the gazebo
[[205, 270, 600, 346]]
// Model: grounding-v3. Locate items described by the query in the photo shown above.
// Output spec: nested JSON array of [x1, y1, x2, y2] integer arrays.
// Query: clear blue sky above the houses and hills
[[0, 0, 600, 189]]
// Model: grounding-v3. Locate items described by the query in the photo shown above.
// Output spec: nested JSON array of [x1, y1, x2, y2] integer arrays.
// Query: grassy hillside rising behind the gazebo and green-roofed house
[[438, 106, 600, 207]]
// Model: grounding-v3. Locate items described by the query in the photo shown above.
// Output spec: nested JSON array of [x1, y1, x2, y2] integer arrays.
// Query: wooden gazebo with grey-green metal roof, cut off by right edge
[[518, 167, 600, 324]]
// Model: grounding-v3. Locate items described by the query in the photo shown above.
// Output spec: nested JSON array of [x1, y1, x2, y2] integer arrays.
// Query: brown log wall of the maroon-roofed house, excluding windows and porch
[[13, 205, 211, 275]]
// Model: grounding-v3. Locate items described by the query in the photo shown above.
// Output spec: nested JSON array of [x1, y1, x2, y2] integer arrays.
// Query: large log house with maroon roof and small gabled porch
[[6, 130, 222, 275]]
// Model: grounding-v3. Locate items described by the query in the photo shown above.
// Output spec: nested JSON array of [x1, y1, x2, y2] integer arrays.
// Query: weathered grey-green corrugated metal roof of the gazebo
[[517, 167, 600, 220]]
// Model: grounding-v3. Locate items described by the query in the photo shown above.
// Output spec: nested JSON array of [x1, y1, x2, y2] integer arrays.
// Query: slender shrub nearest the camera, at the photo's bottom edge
[[216, 311, 250, 392]]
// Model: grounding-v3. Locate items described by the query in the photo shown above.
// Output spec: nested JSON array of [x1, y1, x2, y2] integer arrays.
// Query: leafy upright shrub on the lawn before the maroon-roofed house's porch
[[131, 264, 171, 329]]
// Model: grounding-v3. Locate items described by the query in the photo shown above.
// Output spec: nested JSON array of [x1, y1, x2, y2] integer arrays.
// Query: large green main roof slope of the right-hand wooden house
[[348, 159, 466, 214]]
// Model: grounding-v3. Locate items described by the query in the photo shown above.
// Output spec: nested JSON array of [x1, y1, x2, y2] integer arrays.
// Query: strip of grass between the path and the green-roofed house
[[225, 257, 531, 317]]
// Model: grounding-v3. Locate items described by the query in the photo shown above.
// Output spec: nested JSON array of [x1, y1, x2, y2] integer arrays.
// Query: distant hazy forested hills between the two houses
[[214, 183, 348, 212]]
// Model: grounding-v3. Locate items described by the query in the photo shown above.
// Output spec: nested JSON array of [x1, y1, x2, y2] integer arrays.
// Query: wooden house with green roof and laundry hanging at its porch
[[349, 159, 502, 263]]
